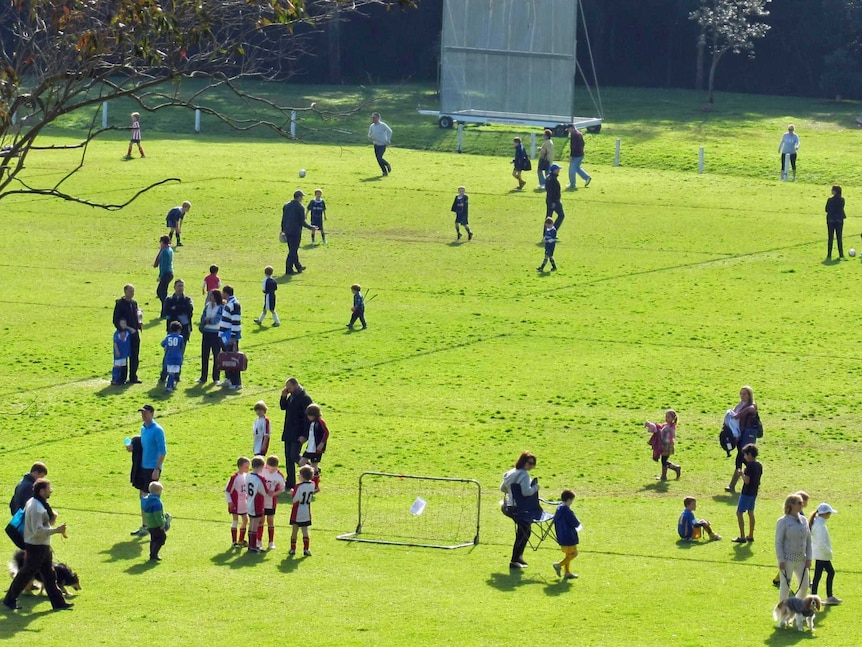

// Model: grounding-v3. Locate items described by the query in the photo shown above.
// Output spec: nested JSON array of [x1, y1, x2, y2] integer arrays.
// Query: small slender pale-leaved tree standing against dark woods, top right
[[689, 0, 771, 105]]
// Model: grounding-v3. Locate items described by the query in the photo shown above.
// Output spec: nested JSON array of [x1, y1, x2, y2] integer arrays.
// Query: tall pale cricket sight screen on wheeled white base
[[419, 0, 602, 142]]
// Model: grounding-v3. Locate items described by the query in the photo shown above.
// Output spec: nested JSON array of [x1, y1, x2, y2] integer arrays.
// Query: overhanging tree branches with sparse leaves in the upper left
[[0, 0, 419, 209]]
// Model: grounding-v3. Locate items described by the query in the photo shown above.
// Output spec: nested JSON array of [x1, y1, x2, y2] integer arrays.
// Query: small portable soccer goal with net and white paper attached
[[338, 472, 482, 549]]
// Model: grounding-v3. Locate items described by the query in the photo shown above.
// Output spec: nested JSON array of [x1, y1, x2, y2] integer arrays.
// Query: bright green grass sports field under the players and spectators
[[0, 89, 862, 647]]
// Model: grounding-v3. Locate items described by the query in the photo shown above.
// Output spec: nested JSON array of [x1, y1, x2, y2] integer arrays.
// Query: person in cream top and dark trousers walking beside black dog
[[3, 479, 75, 611]]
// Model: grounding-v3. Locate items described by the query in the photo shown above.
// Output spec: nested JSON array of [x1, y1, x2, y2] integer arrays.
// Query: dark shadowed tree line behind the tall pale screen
[[298, 0, 862, 99]]
